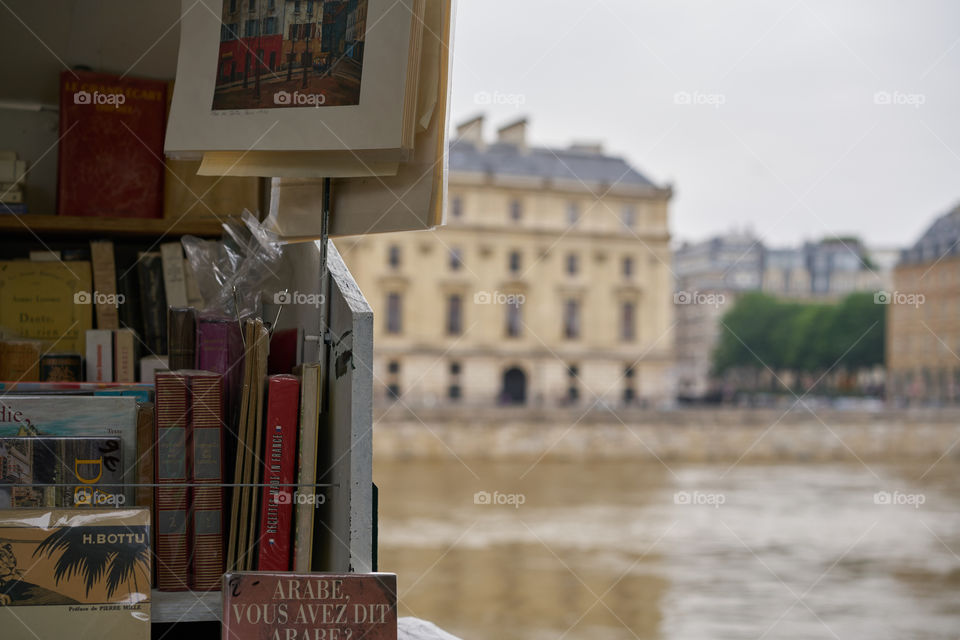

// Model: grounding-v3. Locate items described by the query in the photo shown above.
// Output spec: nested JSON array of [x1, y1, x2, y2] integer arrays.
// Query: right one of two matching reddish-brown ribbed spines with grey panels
[[188, 375, 224, 591]]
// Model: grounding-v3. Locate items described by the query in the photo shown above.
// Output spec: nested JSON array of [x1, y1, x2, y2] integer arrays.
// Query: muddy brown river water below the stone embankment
[[374, 460, 960, 640]]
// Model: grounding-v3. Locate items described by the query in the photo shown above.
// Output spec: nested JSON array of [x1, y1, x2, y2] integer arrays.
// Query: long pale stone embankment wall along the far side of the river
[[374, 405, 960, 462]]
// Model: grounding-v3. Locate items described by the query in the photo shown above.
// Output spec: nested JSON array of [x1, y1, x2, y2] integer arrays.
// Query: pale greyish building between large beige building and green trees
[[673, 234, 764, 399]]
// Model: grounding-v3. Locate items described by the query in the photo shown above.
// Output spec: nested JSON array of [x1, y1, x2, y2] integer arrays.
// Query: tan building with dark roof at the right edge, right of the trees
[[877, 205, 960, 404]]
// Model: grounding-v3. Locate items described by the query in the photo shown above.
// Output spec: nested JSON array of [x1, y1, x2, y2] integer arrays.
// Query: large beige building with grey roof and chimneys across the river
[[337, 118, 673, 409]]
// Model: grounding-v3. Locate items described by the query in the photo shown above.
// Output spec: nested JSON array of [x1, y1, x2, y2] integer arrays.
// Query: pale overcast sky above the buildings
[[452, 0, 960, 246]]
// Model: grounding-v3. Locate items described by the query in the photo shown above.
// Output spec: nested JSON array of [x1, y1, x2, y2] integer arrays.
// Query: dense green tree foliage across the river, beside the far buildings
[[713, 293, 885, 374]]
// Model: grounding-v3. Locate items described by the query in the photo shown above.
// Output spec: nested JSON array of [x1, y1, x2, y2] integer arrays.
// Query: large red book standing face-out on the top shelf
[[57, 71, 167, 218]]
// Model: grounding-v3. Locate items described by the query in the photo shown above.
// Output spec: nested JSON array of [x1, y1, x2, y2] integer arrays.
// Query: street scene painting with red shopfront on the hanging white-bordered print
[[213, 0, 367, 111]]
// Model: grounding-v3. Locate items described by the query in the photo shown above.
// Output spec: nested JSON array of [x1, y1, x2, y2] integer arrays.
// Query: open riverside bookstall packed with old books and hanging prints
[[0, 0, 453, 639]]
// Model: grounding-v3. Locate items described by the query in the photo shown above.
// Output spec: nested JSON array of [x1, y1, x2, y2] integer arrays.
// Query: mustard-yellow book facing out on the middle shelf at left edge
[[0, 261, 93, 353]]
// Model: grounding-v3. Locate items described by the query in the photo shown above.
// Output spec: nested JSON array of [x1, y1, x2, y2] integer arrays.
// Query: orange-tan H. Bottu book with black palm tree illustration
[[0, 508, 151, 640]]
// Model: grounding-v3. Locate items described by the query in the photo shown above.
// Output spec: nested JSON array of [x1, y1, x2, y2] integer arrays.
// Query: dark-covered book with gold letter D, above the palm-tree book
[[0, 436, 124, 509]]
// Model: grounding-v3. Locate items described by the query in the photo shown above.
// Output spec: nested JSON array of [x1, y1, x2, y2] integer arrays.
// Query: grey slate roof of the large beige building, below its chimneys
[[449, 138, 656, 188]]
